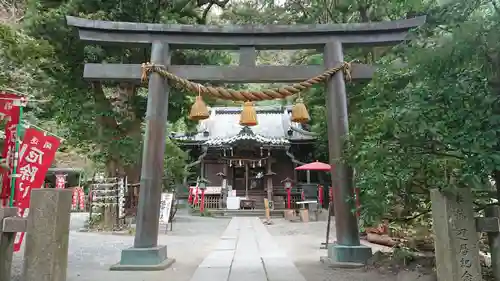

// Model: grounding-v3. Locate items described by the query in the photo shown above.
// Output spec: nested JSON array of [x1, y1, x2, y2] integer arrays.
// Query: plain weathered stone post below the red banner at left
[[23, 188, 72, 281]]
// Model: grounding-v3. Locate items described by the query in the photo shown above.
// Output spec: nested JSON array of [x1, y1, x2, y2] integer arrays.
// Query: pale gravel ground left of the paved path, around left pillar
[[13, 210, 229, 281]]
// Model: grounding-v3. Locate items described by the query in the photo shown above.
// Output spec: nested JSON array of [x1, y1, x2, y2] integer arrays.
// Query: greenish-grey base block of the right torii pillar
[[328, 244, 372, 264]]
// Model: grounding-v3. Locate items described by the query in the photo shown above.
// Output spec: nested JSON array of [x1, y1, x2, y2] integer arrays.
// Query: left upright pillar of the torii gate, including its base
[[111, 41, 174, 270]]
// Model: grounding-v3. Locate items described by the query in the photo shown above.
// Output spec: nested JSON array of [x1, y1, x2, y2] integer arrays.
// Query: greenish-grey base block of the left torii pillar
[[110, 246, 175, 271]]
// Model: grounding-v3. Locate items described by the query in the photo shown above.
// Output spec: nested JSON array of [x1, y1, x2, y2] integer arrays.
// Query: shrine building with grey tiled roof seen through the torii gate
[[170, 106, 318, 209]]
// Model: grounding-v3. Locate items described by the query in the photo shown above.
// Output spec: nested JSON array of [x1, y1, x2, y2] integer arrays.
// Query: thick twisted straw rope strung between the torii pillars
[[141, 62, 351, 101]]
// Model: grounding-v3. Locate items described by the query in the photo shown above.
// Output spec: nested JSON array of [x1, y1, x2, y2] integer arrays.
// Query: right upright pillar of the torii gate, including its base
[[323, 41, 371, 262]]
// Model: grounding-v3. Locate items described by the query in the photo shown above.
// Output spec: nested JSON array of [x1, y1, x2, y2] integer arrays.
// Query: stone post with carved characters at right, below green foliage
[[431, 188, 482, 281]]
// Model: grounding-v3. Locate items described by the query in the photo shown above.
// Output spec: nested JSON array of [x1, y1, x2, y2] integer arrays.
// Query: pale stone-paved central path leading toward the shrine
[[190, 217, 305, 281]]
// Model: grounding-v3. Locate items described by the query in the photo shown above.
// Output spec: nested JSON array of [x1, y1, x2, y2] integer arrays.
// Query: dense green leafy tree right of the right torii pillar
[[348, 1, 500, 222]]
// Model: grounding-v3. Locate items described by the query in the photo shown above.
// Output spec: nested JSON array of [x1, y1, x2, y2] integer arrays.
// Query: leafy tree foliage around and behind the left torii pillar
[[15, 0, 229, 184]]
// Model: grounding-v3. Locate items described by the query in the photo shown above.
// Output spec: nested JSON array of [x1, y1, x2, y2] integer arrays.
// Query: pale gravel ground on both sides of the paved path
[[7, 210, 428, 281]]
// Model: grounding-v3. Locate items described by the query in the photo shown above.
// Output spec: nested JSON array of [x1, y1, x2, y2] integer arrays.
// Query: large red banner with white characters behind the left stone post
[[14, 128, 61, 208]]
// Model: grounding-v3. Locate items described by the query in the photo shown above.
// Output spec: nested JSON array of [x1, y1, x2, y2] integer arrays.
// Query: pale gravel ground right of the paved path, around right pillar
[[267, 219, 402, 281]]
